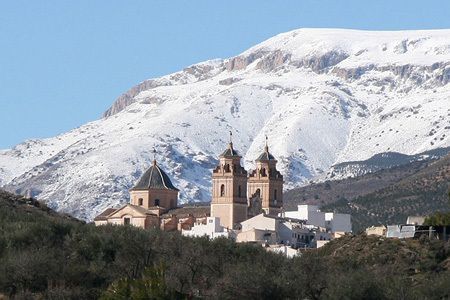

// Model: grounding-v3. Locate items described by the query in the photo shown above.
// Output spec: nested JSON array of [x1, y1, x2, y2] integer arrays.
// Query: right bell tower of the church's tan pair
[[248, 136, 283, 215]]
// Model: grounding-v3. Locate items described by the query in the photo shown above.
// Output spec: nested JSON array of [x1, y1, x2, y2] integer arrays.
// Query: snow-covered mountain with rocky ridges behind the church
[[0, 29, 450, 220]]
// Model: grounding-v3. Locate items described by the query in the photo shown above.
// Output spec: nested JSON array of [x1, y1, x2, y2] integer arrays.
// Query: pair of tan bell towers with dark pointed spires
[[211, 132, 283, 229]]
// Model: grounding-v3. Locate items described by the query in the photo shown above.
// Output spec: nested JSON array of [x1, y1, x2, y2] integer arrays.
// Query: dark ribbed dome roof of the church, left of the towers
[[131, 161, 178, 191]]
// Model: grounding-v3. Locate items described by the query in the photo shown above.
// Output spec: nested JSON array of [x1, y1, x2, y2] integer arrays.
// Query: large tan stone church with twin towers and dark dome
[[94, 132, 283, 231]]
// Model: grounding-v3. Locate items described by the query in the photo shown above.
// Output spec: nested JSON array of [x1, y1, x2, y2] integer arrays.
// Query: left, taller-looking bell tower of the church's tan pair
[[211, 132, 247, 229]]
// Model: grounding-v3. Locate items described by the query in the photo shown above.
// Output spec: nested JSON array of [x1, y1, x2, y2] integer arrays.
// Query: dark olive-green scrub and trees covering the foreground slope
[[0, 192, 450, 299]]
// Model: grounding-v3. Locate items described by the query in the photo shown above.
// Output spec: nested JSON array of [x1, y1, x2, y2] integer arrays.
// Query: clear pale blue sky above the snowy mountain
[[0, 0, 450, 149]]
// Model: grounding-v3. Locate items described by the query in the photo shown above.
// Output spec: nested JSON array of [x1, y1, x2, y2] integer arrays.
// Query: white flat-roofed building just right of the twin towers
[[282, 205, 352, 233]]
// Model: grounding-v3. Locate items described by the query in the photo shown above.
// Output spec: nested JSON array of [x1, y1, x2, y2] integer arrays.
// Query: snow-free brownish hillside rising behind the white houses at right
[[285, 156, 450, 232]]
